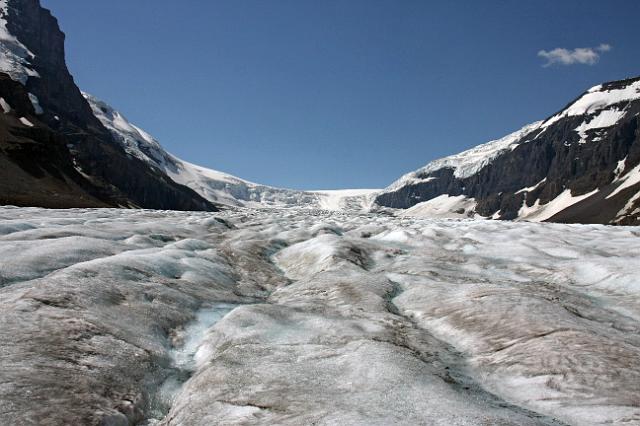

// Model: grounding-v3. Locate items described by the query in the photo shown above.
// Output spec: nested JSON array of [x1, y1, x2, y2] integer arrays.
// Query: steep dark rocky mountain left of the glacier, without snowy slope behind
[[0, 0, 216, 210]]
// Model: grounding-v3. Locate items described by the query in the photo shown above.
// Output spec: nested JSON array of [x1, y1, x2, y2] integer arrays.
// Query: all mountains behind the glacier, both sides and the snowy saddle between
[[0, 0, 640, 224]]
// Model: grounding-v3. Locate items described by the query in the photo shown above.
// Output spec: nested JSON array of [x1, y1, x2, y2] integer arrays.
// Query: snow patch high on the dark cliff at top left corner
[[0, 0, 39, 84]]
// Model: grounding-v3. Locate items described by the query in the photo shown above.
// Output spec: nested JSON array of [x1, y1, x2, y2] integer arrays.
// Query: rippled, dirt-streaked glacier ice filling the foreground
[[0, 207, 640, 425]]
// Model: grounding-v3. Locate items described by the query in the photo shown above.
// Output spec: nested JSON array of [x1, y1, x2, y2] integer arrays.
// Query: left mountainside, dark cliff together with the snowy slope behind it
[[0, 0, 375, 210]]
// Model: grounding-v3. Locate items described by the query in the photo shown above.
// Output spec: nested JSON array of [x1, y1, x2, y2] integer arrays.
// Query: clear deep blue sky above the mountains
[[42, 0, 640, 189]]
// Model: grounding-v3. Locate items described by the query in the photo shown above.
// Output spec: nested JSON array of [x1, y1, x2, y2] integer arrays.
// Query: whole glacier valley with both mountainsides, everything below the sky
[[0, 0, 640, 426]]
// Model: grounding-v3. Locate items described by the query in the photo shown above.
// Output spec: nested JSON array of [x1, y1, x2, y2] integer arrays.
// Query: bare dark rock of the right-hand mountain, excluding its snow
[[376, 78, 640, 224]]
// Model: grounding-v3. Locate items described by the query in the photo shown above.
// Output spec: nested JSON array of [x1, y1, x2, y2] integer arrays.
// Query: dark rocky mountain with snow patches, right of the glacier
[[375, 77, 640, 224]]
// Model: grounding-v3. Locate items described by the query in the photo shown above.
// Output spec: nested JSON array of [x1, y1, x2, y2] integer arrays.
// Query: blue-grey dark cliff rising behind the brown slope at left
[[0, 0, 216, 211]]
